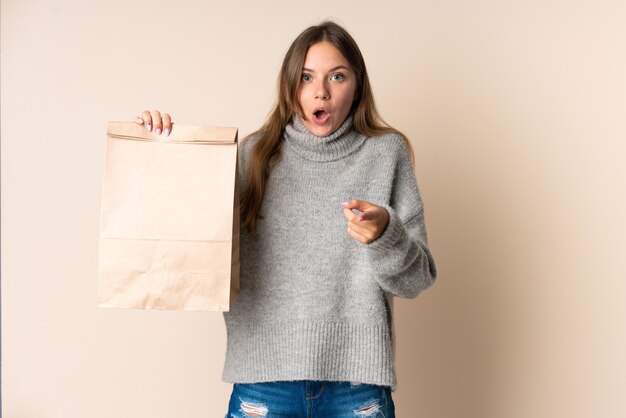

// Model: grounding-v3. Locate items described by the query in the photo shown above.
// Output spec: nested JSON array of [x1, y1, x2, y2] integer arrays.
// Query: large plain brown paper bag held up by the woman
[[97, 122, 239, 311]]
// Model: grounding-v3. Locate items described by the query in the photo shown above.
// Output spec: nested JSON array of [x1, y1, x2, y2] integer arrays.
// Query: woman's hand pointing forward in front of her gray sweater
[[342, 200, 389, 244]]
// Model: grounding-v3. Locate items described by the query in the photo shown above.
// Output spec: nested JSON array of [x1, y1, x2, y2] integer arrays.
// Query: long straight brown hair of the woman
[[241, 21, 413, 233]]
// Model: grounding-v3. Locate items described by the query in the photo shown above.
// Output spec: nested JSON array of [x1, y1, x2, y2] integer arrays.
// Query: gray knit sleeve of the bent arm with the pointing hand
[[365, 139, 437, 298]]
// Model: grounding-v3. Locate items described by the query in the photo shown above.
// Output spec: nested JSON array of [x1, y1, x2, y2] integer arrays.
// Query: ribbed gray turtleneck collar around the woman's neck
[[284, 115, 365, 162]]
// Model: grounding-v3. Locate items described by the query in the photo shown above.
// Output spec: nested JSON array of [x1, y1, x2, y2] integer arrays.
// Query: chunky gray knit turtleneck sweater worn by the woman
[[223, 116, 436, 389]]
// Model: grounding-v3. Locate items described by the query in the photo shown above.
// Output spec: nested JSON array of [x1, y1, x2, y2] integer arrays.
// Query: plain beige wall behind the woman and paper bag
[[1, 0, 626, 418]]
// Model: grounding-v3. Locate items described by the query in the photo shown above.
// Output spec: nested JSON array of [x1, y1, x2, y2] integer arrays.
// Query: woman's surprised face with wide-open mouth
[[298, 41, 357, 136]]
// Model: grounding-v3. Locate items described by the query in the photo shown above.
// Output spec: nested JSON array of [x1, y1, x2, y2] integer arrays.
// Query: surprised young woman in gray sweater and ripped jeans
[[136, 22, 436, 418]]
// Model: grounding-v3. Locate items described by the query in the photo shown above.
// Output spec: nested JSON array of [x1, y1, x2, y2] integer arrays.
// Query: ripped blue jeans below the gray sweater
[[226, 380, 395, 418]]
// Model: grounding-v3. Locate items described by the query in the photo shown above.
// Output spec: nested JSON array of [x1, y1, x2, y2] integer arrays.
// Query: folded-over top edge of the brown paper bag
[[107, 122, 237, 144]]
